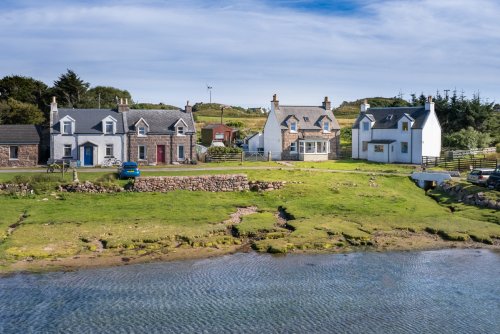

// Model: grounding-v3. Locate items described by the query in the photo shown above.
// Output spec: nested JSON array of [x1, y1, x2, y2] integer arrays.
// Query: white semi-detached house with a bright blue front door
[[49, 98, 126, 167]]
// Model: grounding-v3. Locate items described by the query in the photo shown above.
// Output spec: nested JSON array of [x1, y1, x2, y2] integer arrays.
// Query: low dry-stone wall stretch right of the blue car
[[130, 174, 250, 192]]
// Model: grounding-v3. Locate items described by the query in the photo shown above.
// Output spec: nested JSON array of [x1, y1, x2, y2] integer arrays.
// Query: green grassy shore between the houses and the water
[[0, 167, 500, 272]]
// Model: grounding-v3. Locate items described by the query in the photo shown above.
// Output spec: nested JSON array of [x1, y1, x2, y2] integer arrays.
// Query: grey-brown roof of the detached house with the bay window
[[275, 105, 340, 130]]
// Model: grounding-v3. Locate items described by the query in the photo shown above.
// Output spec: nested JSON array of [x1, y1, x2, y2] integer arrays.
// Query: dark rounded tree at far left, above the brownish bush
[[0, 75, 48, 110]]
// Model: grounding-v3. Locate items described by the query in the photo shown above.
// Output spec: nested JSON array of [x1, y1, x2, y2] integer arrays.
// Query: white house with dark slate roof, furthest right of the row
[[352, 96, 441, 164]]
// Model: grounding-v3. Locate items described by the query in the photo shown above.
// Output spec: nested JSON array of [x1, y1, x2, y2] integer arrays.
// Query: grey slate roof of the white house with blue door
[[53, 109, 125, 134]]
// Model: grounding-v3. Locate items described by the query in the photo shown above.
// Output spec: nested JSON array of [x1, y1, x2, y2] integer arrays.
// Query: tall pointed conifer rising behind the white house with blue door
[[54, 69, 90, 108]]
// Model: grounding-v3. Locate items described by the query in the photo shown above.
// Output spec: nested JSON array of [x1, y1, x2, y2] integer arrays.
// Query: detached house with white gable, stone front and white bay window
[[263, 94, 340, 161]]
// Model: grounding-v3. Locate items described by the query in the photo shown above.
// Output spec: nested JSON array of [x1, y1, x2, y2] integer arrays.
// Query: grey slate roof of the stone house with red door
[[126, 109, 196, 134]]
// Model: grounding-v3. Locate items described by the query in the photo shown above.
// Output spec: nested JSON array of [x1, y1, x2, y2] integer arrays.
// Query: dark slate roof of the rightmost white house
[[352, 106, 430, 129]]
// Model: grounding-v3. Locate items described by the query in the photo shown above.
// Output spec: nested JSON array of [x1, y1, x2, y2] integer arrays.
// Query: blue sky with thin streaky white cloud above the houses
[[0, 0, 500, 107]]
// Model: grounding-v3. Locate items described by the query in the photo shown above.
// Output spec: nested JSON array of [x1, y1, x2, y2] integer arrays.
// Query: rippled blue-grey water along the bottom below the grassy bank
[[0, 250, 500, 333]]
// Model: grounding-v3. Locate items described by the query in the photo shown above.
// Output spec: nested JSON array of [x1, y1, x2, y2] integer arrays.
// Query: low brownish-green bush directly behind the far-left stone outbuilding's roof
[[0, 98, 44, 124]]
